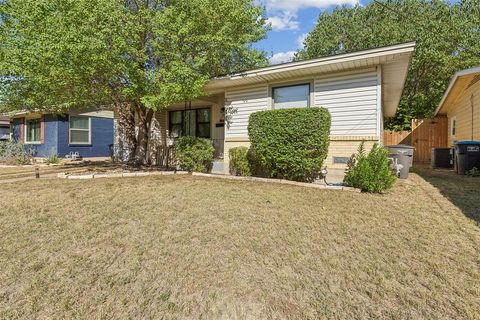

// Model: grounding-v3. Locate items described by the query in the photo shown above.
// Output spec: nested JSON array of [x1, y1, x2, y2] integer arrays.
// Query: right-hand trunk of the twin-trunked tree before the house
[[133, 105, 153, 165]]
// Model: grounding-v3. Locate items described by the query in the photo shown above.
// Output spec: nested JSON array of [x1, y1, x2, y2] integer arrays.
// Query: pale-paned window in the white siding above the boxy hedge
[[272, 84, 310, 109]]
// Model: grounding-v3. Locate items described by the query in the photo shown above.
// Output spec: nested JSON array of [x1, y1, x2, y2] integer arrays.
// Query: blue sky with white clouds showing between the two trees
[[255, 0, 371, 64]]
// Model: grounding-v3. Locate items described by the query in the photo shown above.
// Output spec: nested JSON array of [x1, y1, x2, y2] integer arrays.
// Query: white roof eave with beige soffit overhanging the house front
[[206, 42, 415, 117]]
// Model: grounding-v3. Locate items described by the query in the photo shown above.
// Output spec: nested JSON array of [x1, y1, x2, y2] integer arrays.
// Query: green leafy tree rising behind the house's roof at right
[[297, 0, 480, 130]]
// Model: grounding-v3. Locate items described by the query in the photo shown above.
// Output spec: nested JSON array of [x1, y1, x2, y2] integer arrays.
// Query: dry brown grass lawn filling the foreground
[[0, 169, 480, 319]]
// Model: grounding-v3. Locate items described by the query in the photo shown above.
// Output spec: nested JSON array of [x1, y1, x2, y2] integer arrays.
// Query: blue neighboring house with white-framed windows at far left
[[11, 111, 114, 158]]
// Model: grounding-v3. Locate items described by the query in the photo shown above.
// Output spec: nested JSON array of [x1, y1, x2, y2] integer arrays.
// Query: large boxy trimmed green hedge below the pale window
[[248, 108, 331, 182]]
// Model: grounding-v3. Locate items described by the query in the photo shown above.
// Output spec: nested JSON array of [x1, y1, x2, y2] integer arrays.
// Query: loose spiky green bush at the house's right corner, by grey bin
[[343, 141, 395, 193]]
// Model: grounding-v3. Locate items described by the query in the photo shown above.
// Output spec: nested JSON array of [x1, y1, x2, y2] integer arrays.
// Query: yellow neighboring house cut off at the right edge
[[435, 67, 480, 146]]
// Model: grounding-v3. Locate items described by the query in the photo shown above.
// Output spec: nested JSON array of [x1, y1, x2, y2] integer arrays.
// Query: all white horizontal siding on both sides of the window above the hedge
[[225, 68, 381, 139]]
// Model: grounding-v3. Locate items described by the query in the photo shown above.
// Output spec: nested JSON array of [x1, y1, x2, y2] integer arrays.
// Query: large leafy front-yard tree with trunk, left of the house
[[0, 0, 266, 164]]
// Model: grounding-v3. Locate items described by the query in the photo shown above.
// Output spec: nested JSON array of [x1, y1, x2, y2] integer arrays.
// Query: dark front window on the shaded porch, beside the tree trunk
[[169, 109, 210, 138]]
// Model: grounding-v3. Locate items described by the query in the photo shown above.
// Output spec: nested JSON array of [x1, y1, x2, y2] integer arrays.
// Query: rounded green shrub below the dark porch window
[[175, 137, 215, 172]]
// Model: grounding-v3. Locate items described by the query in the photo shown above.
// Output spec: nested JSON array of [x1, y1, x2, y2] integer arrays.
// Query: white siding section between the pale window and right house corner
[[314, 69, 381, 136]]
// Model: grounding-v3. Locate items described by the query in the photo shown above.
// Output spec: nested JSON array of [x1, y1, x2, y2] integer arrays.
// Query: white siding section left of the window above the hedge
[[225, 85, 269, 138]]
